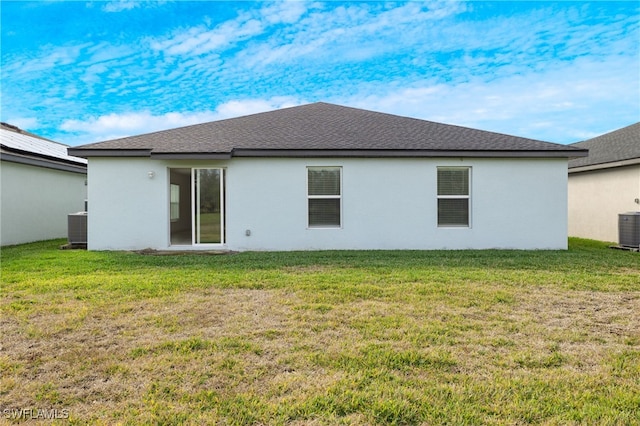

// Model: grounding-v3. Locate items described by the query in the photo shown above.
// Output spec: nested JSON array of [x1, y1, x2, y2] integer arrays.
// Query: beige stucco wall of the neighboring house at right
[[568, 165, 640, 242]]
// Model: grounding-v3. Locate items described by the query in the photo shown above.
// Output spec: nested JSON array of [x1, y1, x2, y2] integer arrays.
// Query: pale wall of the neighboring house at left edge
[[0, 161, 87, 246]]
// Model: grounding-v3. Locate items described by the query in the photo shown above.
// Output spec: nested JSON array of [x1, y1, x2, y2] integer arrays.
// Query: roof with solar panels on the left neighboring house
[[0, 123, 87, 174]]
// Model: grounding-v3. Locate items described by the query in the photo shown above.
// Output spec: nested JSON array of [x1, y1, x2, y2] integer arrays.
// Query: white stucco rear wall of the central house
[[88, 157, 567, 251]]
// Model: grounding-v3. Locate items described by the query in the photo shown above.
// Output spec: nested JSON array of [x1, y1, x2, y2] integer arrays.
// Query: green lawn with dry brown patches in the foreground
[[0, 239, 640, 425]]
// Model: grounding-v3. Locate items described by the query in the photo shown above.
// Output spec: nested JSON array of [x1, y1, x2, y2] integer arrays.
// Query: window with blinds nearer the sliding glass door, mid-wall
[[307, 167, 342, 228]]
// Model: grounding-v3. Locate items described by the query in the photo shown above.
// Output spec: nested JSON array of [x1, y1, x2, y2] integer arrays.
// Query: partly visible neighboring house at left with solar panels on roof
[[0, 123, 87, 246]]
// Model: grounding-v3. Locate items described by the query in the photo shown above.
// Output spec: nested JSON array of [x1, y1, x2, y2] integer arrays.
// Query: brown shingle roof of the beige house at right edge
[[569, 123, 640, 172]]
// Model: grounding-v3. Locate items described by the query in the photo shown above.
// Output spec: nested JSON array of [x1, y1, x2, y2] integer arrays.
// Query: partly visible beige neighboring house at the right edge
[[569, 123, 640, 242]]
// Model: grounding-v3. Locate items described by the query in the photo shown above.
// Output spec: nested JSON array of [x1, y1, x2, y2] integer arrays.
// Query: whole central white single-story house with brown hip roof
[[69, 103, 586, 250]]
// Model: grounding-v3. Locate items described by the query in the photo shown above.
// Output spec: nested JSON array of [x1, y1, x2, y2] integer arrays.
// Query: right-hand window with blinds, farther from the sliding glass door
[[438, 167, 471, 227]]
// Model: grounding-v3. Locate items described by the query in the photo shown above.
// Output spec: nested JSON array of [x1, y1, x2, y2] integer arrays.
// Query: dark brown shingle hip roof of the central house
[[69, 102, 586, 159]]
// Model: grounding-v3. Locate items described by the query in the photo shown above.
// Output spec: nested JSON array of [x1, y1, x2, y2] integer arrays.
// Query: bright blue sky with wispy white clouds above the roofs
[[0, 0, 640, 145]]
